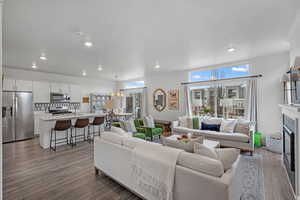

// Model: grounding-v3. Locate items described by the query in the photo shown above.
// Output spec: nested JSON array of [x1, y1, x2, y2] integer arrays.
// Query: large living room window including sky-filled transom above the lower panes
[[190, 64, 249, 118]]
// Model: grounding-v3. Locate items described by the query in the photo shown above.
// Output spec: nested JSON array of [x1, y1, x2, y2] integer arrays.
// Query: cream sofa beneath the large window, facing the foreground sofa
[[172, 116, 255, 154]]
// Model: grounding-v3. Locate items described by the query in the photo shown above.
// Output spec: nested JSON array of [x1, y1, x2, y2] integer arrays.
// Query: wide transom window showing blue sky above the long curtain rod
[[190, 64, 249, 82]]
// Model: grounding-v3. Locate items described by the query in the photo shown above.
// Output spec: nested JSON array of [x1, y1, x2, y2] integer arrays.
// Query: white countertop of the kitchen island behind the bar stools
[[40, 113, 105, 121]]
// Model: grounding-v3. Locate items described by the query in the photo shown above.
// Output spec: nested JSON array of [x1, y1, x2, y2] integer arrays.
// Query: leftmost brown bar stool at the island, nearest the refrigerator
[[50, 120, 72, 151]]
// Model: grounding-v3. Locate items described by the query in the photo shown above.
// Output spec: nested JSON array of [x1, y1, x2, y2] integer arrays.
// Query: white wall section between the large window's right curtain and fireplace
[[250, 52, 289, 135]]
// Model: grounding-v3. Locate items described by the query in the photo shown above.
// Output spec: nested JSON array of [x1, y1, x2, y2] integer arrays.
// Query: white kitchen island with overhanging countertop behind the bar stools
[[37, 113, 105, 149]]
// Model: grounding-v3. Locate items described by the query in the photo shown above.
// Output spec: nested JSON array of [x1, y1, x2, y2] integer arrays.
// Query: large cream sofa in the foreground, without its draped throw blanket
[[94, 132, 242, 200]]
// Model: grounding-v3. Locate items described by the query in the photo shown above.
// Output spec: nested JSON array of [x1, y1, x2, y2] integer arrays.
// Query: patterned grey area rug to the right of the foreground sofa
[[238, 155, 265, 200]]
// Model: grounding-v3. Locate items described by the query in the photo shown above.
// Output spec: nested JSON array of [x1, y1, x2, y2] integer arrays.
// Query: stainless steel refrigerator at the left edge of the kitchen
[[2, 91, 34, 143]]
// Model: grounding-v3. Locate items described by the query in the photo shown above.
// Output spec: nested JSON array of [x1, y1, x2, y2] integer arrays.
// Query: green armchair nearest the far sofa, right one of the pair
[[134, 119, 164, 141]]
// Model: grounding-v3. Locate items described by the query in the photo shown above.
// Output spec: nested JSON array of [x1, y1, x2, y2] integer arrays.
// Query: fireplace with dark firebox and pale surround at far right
[[283, 115, 297, 191]]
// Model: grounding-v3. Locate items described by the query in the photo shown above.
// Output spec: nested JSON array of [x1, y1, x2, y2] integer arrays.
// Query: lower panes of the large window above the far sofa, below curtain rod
[[190, 81, 248, 119]]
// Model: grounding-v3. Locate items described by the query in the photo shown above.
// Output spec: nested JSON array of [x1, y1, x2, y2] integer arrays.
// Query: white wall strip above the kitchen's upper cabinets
[[3, 67, 116, 112]]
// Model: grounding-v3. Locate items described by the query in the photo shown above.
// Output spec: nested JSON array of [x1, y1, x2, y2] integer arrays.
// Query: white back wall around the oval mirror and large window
[[118, 52, 289, 135]]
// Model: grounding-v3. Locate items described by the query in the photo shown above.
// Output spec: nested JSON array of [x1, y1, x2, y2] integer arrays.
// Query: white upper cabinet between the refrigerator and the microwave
[[33, 81, 50, 103]]
